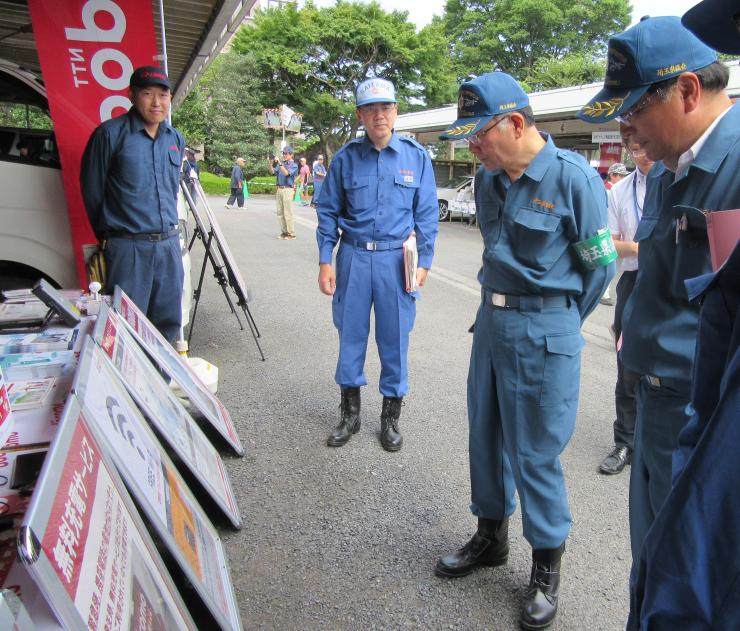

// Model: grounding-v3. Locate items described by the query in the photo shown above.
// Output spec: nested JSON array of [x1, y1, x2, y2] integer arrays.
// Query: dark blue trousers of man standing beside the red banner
[[105, 236, 184, 342]]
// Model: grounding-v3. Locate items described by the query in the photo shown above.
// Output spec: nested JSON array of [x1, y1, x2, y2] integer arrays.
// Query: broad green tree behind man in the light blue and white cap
[[232, 0, 454, 156]]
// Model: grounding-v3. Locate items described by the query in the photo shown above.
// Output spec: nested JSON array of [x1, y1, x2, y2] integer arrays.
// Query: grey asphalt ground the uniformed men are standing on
[[191, 196, 630, 631]]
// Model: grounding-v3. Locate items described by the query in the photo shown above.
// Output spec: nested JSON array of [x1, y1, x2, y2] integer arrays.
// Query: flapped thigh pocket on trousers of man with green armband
[[540, 332, 585, 407]]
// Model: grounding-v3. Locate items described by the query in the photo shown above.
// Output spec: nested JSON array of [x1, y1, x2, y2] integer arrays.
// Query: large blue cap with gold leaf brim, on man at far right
[[576, 17, 717, 123]]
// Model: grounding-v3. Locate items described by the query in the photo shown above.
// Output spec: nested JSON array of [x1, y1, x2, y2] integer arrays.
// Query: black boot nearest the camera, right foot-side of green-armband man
[[519, 543, 565, 631]]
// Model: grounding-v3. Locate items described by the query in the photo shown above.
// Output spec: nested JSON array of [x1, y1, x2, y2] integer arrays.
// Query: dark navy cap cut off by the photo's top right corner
[[681, 0, 740, 55]]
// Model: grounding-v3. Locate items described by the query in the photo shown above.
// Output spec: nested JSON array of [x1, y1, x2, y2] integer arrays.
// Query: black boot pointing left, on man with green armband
[[434, 517, 509, 578]]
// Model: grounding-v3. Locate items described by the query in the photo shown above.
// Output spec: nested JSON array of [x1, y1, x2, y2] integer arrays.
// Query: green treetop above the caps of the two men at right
[[443, 0, 630, 80]]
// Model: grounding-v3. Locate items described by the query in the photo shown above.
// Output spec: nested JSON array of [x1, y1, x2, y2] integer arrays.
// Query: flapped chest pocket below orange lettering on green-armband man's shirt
[[511, 206, 567, 271]]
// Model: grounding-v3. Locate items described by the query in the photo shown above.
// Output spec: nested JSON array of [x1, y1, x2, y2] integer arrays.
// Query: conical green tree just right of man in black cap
[[173, 52, 271, 174]]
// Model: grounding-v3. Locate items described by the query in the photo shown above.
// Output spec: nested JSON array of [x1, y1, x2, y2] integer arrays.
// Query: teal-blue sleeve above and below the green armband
[[573, 176, 616, 322]]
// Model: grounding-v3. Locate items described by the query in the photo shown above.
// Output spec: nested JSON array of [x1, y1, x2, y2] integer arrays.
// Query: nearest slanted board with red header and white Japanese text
[[18, 397, 196, 631]]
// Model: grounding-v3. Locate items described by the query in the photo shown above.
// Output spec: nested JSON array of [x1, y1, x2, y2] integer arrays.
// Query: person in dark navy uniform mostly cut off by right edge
[[627, 0, 740, 630]]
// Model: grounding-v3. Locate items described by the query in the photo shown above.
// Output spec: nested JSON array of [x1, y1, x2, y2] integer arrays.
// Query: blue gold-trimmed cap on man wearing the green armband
[[439, 72, 529, 140]]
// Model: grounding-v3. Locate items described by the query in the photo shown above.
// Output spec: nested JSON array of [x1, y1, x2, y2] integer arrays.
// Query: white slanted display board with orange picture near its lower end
[[75, 343, 241, 630]]
